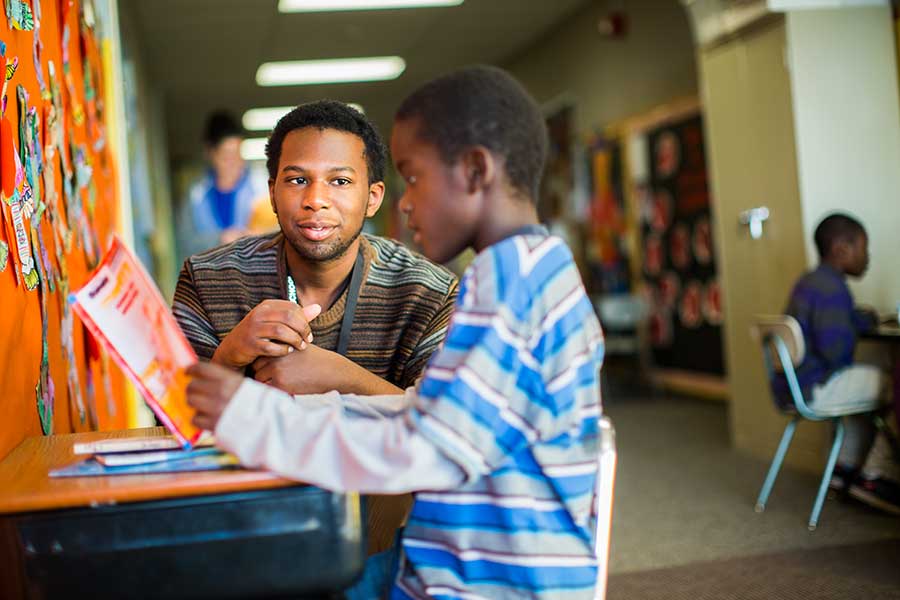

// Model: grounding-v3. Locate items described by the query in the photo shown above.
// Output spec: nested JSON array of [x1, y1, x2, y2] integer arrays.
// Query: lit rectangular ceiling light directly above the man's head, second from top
[[256, 56, 406, 86]]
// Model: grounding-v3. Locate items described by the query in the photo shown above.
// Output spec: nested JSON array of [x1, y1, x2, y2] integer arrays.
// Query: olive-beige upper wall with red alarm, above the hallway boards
[[505, 0, 697, 134]]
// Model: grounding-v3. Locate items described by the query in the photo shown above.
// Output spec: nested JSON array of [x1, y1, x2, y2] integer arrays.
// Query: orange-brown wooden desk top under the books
[[0, 427, 297, 514]]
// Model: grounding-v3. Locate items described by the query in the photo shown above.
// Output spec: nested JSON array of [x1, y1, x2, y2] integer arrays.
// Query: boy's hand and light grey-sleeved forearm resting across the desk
[[188, 365, 464, 494]]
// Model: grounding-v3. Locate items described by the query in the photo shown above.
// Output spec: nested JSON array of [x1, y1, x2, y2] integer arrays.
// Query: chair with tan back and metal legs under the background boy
[[751, 315, 891, 531]]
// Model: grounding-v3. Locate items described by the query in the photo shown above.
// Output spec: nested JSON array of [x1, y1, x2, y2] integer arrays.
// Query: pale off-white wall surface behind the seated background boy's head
[[787, 7, 900, 312]]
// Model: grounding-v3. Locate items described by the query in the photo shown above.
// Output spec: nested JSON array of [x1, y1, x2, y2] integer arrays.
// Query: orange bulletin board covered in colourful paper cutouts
[[0, 0, 127, 458]]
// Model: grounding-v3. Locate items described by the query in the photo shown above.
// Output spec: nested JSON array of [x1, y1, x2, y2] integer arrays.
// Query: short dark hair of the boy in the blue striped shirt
[[396, 66, 548, 201]]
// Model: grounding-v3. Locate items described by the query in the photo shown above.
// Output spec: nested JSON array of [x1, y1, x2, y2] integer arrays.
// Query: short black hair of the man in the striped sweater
[[266, 100, 387, 184]]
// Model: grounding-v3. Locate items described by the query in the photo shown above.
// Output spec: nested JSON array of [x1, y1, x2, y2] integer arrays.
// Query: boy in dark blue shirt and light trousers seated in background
[[775, 214, 900, 514]]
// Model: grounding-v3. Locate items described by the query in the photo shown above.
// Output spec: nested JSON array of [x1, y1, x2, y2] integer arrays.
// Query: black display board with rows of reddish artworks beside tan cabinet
[[639, 115, 724, 375]]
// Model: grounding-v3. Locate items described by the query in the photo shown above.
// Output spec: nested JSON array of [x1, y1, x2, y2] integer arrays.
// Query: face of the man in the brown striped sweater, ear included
[[269, 127, 384, 262]]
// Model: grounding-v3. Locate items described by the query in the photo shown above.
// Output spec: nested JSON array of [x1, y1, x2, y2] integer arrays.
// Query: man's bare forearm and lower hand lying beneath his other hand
[[253, 344, 403, 395]]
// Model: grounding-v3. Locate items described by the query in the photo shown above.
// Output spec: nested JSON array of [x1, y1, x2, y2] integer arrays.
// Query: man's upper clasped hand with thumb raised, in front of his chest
[[212, 300, 322, 370]]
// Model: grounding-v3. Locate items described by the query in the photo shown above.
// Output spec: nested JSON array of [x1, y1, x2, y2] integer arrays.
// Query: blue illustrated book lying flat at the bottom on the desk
[[50, 448, 241, 477]]
